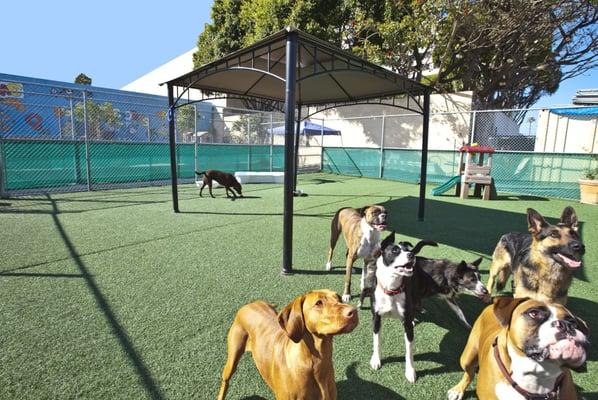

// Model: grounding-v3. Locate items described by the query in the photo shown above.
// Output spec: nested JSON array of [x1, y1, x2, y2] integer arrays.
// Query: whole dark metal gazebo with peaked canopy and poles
[[166, 27, 432, 274]]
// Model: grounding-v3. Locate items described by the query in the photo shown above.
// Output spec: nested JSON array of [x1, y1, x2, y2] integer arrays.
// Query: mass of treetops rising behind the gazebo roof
[[194, 0, 598, 109]]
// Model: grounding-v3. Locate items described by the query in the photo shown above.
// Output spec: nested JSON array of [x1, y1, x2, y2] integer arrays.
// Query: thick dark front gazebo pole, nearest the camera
[[282, 32, 297, 275]]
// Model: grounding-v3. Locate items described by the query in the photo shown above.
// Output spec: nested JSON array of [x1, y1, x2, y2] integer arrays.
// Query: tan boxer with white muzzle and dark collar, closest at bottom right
[[448, 297, 588, 400]]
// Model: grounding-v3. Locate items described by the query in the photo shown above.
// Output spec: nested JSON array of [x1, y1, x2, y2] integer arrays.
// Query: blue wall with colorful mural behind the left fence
[[0, 73, 212, 142]]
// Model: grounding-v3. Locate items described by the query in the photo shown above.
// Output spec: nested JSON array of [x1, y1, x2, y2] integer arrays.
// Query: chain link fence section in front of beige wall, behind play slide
[[323, 107, 598, 200]]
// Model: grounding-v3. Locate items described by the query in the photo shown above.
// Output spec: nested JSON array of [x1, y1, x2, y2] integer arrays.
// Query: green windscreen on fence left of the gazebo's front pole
[[0, 140, 284, 191]]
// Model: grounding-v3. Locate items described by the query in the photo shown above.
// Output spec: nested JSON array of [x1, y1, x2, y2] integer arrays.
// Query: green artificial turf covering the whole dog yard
[[0, 174, 598, 399]]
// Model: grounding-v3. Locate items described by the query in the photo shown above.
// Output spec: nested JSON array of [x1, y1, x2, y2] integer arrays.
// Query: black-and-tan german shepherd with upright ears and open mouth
[[487, 207, 585, 305]]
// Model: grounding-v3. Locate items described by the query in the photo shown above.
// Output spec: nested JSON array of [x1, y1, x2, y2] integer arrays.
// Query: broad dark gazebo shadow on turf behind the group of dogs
[[381, 196, 588, 282]]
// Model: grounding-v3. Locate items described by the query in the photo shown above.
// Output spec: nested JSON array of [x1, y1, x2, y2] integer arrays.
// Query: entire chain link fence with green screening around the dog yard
[[0, 76, 598, 199]]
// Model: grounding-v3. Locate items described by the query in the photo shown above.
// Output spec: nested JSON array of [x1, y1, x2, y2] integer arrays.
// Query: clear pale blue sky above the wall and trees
[[0, 0, 598, 107]]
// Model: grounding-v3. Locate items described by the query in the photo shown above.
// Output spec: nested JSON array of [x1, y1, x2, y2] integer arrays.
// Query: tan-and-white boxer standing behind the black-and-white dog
[[326, 205, 387, 303]]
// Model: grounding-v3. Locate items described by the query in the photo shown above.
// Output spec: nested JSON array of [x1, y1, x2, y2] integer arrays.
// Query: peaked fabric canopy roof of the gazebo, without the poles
[[167, 28, 431, 113]]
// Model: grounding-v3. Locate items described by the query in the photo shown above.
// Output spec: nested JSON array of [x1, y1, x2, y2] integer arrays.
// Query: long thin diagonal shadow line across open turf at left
[[41, 195, 164, 400]]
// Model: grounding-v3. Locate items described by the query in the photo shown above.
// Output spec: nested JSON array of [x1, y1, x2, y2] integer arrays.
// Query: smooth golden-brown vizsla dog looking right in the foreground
[[218, 290, 358, 400]]
